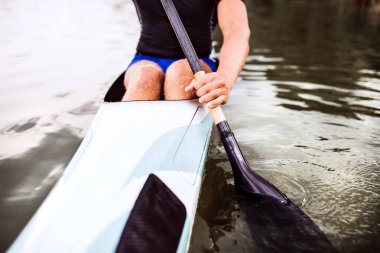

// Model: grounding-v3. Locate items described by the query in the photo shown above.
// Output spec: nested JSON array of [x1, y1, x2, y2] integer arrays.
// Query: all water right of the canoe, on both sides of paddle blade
[[190, 0, 380, 252]]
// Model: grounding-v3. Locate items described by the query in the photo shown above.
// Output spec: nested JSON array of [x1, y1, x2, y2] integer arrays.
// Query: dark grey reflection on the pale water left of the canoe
[[0, 129, 81, 251]]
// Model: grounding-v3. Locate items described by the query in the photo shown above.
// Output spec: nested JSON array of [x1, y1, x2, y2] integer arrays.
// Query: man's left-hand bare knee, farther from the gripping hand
[[123, 60, 165, 101]]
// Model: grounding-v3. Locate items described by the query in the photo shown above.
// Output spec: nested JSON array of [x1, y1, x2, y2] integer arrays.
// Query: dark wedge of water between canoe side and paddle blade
[[190, 136, 254, 252]]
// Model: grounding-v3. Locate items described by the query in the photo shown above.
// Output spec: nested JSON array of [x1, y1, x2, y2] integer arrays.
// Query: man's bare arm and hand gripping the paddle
[[185, 0, 250, 108]]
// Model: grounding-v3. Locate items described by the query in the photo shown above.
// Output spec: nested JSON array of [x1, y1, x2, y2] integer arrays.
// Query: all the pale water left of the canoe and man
[[0, 0, 139, 252]]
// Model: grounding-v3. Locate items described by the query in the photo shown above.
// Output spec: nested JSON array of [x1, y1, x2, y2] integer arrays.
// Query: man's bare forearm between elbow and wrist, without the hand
[[217, 29, 249, 89]]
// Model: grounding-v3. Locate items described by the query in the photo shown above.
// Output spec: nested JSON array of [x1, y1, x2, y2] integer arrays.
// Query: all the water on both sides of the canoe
[[0, 0, 380, 252]]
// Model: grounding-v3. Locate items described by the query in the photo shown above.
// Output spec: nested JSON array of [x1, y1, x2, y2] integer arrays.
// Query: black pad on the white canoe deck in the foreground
[[116, 174, 186, 253]]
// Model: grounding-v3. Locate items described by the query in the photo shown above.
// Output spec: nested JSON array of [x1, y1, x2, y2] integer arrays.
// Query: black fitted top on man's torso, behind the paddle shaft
[[133, 0, 219, 58]]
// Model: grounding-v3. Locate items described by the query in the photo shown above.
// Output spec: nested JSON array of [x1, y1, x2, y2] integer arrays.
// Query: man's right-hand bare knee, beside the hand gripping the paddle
[[164, 59, 211, 100]]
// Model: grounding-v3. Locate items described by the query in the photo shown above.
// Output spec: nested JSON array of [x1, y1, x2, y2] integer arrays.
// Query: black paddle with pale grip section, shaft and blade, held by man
[[161, 0, 336, 252]]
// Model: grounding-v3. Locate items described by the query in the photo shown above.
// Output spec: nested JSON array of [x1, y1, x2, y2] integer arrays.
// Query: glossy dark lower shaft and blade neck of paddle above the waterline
[[216, 121, 289, 203]]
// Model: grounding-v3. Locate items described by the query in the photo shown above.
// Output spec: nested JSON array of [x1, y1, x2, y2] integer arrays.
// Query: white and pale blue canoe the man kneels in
[[8, 72, 212, 253]]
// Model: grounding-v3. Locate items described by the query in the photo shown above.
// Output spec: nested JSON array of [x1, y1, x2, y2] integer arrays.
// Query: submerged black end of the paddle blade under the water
[[238, 193, 337, 253]]
